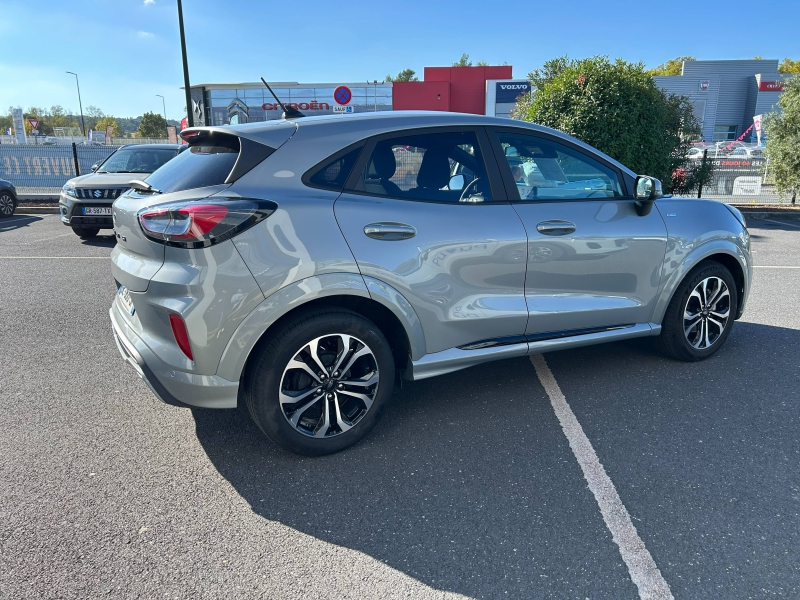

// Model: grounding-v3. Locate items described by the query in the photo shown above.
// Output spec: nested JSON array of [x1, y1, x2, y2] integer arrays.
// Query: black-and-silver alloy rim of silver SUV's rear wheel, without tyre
[[279, 333, 379, 438]]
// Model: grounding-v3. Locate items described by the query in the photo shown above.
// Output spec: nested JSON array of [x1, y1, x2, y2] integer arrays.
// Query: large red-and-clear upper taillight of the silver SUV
[[139, 198, 278, 248]]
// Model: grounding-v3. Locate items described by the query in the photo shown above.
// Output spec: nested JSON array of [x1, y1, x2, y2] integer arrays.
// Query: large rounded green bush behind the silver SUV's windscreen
[[514, 56, 700, 193]]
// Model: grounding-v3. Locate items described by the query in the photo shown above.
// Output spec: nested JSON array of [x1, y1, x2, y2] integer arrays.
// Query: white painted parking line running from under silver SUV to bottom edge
[[531, 354, 672, 600]]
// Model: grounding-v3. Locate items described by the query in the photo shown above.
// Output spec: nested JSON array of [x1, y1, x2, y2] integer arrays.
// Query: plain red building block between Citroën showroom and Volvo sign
[[392, 66, 511, 115]]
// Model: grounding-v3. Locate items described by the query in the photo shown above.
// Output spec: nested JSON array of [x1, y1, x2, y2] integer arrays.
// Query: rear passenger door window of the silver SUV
[[359, 131, 492, 202]]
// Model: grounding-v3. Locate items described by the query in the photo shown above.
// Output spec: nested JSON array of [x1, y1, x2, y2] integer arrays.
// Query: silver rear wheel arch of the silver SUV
[[212, 273, 424, 381]]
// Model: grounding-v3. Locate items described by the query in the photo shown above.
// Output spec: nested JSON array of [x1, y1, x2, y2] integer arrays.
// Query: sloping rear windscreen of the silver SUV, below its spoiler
[[147, 144, 239, 193]]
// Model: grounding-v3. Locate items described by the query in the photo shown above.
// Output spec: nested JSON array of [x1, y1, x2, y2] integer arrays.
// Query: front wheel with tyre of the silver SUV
[[656, 261, 738, 362]]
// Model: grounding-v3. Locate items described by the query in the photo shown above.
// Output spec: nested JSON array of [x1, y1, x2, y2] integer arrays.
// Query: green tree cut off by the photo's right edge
[[764, 77, 800, 204]]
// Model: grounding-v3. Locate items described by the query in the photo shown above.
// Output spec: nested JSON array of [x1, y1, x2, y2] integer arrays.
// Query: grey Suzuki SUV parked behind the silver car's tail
[[59, 144, 183, 239]]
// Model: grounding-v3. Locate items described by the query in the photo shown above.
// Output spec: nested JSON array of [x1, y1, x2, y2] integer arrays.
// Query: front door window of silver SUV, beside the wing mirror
[[497, 133, 623, 200]]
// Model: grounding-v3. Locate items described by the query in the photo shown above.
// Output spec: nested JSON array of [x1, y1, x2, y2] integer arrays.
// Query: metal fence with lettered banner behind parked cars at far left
[[0, 144, 119, 195]]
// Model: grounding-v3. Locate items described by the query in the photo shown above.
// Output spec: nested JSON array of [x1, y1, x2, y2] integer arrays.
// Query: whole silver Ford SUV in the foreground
[[110, 112, 752, 455]]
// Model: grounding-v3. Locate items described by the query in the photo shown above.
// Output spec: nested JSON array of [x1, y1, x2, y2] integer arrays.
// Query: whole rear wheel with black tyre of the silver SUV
[[243, 309, 395, 456]]
